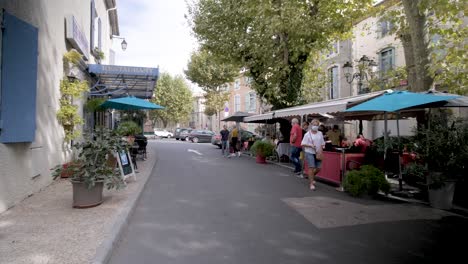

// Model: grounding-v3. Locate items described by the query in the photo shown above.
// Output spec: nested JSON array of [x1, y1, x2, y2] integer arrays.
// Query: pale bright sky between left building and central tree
[[112, 0, 196, 90]]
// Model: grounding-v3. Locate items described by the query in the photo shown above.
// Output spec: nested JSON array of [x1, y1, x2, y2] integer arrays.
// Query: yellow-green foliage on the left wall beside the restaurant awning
[[56, 79, 89, 141]]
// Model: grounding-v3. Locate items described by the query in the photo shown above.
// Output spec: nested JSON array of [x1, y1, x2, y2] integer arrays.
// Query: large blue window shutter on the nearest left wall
[[0, 12, 38, 143]]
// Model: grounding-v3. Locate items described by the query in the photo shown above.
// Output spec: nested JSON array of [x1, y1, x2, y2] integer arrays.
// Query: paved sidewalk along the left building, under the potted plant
[[0, 141, 157, 264]]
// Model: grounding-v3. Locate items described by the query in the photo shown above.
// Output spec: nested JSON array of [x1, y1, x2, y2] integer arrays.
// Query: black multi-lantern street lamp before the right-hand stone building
[[343, 55, 377, 96]]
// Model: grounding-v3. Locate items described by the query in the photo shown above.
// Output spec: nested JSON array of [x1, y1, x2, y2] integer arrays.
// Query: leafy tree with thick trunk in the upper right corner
[[381, 0, 468, 94]]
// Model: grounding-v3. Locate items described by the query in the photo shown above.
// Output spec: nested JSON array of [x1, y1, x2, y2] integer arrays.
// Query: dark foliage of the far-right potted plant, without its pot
[[414, 111, 468, 186]]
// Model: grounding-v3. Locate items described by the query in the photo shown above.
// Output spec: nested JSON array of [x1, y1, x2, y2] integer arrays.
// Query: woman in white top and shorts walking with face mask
[[301, 124, 325, 190]]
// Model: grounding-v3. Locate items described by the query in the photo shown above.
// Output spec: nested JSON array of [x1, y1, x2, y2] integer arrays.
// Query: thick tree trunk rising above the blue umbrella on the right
[[402, 0, 433, 91]]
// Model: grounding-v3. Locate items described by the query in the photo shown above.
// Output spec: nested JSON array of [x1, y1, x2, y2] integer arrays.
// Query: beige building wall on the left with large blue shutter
[[0, 0, 121, 212]]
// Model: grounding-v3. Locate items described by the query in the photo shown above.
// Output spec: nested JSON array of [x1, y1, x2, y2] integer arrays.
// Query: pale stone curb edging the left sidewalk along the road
[[90, 148, 158, 264]]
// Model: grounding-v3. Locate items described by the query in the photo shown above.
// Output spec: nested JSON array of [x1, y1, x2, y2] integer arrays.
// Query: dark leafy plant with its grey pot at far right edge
[[414, 110, 468, 209]]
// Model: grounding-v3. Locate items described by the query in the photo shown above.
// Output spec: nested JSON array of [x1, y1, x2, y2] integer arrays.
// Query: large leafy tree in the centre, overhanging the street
[[189, 0, 372, 109]]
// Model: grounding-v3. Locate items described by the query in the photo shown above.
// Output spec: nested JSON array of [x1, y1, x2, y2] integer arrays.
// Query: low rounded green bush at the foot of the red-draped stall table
[[344, 165, 390, 197]]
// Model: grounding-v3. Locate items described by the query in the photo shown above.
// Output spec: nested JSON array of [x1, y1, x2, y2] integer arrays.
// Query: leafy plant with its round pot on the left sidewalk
[[52, 129, 126, 208]]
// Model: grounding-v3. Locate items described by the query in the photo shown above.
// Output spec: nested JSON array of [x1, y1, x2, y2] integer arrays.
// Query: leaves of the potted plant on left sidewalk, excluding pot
[[52, 129, 127, 189]]
